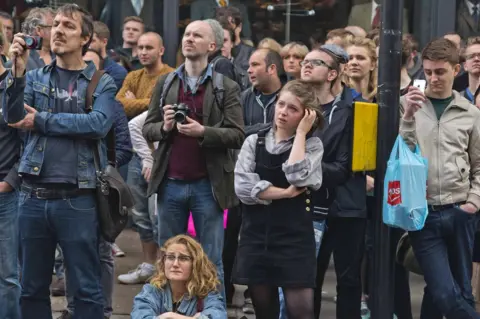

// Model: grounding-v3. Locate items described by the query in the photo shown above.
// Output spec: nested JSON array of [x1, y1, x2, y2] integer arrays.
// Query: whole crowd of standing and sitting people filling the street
[[0, 4, 480, 319]]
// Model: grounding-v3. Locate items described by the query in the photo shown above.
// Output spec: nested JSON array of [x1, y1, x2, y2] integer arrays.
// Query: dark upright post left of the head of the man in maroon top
[[163, 0, 180, 67]]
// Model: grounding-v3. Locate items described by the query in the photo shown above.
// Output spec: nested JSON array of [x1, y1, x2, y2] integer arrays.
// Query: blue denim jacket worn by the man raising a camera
[[0, 60, 117, 188]]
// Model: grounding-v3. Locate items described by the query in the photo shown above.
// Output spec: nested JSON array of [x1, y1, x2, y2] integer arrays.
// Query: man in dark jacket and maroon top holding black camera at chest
[[143, 21, 244, 296]]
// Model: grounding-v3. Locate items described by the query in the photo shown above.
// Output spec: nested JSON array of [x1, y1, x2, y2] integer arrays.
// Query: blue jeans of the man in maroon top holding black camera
[[158, 179, 225, 300]]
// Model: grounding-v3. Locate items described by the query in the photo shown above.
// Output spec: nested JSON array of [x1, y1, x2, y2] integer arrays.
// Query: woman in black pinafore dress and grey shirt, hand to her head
[[233, 81, 323, 319]]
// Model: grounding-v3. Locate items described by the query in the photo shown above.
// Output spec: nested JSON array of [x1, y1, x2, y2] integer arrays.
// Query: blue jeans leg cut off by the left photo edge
[[0, 192, 20, 319]]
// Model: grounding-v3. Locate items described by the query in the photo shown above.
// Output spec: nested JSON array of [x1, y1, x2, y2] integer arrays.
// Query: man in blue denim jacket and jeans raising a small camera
[[3, 4, 116, 319]]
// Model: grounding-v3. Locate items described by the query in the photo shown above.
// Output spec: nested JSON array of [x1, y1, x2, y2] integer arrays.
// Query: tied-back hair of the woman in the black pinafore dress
[[279, 80, 324, 130]]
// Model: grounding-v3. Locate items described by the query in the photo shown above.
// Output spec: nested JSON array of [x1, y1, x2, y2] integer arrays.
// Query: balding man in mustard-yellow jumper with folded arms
[[117, 32, 174, 120]]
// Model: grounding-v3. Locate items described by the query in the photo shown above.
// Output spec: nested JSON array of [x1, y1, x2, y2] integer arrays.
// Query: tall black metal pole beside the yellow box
[[370, 0, 403, 319]]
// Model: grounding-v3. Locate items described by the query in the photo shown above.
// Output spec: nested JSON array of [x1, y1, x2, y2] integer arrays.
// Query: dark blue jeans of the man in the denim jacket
[[19, 192, 103, 319]]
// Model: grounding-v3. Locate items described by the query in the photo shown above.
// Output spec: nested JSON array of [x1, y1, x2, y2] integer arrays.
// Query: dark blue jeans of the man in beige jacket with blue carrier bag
[[409, 208, 480, 319]]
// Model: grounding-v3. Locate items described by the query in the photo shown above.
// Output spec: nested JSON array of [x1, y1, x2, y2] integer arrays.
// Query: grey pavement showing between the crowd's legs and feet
[[51, 230, 424, 319]]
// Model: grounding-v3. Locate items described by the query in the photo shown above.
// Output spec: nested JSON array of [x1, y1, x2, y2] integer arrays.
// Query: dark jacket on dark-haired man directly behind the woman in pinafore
[[240, 87, 277, 137]]
